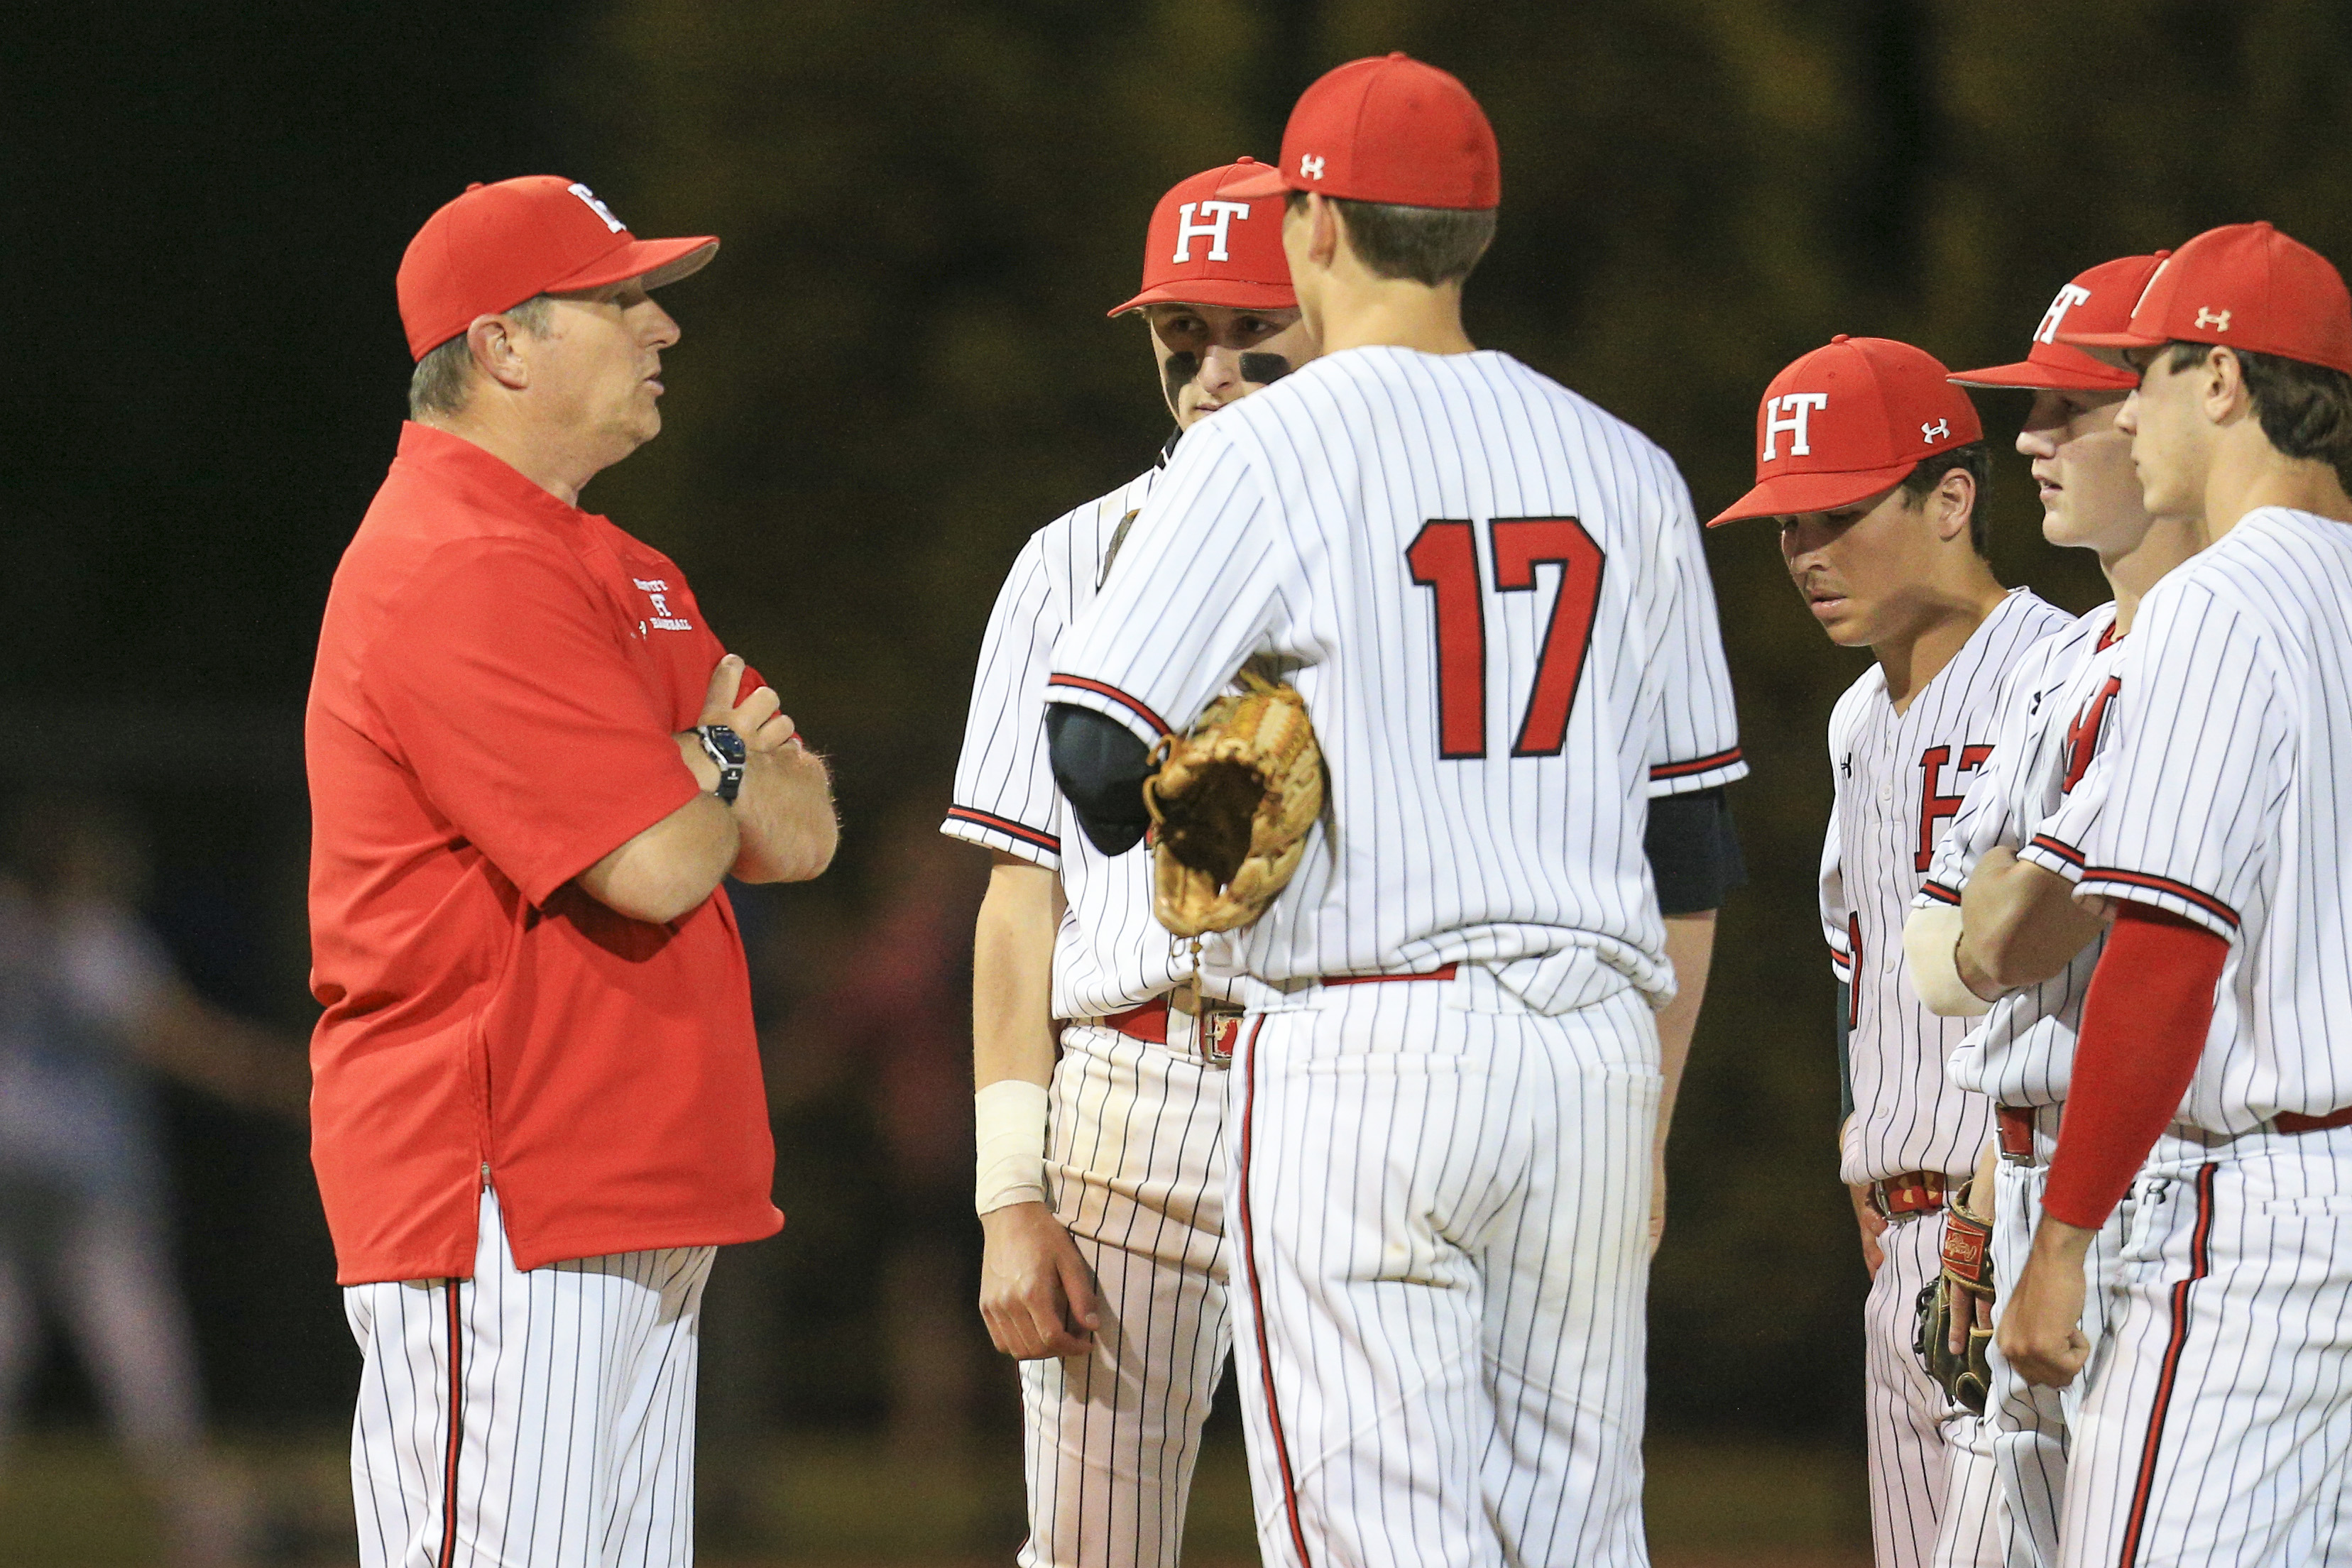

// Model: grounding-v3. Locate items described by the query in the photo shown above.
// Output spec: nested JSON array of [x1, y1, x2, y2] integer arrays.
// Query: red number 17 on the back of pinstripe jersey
[[1404, 517, 1607, 757]]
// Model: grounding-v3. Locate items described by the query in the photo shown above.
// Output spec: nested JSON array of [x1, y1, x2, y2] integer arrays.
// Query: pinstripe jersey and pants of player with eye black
[[941, 468, 1232, 1568]]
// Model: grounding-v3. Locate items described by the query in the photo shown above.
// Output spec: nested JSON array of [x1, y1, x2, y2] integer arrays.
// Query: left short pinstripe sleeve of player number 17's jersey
[[1046, 421, 1303, 740]]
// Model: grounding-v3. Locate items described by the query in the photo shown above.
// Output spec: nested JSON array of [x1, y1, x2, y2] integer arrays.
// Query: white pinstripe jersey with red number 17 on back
[[1049, 348, 1745, 1011]]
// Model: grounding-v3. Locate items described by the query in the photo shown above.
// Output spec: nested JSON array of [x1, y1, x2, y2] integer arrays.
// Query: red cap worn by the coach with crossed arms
[[398, 174, 720, 360]]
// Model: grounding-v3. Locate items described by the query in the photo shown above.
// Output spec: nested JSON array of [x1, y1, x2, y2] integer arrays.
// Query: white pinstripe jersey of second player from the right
[[1915, 602, 2124, 1105]]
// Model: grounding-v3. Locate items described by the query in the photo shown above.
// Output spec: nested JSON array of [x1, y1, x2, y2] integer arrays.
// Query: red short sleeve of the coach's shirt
[[362, 538, 699, 905]]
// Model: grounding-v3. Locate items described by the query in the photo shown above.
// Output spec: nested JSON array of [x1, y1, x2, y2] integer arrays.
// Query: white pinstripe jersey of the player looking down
[[1820, 588, 2067, 1183]]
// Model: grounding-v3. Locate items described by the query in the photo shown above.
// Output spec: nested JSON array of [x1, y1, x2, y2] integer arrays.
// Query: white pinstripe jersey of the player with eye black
[[939, 466, 1218, 1018]]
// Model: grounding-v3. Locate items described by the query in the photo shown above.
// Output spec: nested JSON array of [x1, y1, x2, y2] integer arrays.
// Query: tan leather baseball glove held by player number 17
[[1143, 670, 1324, 936]]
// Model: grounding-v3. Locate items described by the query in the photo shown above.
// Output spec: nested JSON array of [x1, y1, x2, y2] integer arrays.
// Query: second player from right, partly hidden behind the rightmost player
[[1903, 256, 2199, 1568]]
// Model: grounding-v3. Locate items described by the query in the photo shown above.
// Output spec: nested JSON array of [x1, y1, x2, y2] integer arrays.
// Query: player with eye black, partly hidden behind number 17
[[941, 158, 1315, 1568]]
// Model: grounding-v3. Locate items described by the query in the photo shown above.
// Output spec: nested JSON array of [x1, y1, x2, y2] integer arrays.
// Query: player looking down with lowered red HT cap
[[1714, 336, 2065, 1568]]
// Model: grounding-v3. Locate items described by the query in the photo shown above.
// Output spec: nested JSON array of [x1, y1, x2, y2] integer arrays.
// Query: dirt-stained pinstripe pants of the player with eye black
[[1021, 1016, 1232, 1568]]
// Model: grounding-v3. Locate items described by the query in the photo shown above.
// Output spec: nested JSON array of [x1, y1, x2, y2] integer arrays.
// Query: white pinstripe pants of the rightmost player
[[2060, 1129, 2352, 1568]]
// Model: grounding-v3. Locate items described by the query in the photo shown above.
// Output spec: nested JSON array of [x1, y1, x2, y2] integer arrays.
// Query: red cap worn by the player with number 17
[[1227, 52, 1503, 212]]
